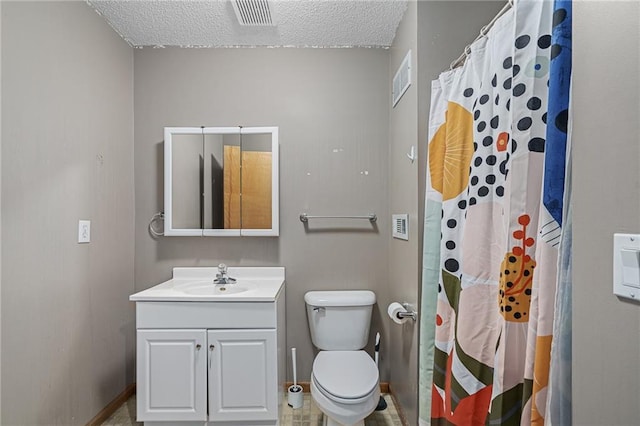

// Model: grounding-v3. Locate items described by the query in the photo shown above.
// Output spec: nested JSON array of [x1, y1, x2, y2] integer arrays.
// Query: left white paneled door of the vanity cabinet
[[137, 330, 207, 422]]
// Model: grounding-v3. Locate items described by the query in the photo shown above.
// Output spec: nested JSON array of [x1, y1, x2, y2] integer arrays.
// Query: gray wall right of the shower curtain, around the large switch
[[573, 1, 640, 425]]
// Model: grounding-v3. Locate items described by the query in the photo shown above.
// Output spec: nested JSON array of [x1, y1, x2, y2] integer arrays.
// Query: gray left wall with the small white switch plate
[[1, 2, 134, 425]]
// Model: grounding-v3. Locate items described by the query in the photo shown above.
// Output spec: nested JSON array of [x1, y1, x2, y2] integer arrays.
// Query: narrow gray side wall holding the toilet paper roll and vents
[[385, 1, 420, 424]]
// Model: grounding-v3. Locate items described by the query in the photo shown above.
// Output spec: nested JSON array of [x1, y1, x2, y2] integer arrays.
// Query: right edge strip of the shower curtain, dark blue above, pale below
[[543, 0, 573, 425]]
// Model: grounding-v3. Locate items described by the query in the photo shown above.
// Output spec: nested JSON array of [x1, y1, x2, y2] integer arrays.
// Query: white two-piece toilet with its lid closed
[[304, 290, 380, 426]]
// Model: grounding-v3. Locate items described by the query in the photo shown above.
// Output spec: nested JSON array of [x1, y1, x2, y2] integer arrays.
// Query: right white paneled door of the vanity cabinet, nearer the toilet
[[207, 330, 278, 421]]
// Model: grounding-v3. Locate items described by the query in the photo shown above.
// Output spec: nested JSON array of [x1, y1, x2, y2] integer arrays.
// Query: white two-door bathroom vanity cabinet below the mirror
[[131, 268, 286, 426]]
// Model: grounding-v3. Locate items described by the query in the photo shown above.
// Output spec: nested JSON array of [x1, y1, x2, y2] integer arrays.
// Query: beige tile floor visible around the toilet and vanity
[[103, 393, 402, 426]]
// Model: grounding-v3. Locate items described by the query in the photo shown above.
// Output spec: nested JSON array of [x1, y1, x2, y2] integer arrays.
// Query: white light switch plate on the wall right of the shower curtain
[[613, 234, 640, 301]]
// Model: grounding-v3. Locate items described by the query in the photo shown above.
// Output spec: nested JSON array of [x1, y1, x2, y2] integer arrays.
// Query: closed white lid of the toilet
[[313, 351, 378, 399]]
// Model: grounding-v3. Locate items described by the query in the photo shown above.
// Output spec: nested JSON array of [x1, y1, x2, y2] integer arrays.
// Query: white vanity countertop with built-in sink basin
[[129, 266, 284, 302]]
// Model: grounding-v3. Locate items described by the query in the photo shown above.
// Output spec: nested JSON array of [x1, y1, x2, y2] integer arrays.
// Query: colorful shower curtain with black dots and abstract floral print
[[420, 0, 571, 426]]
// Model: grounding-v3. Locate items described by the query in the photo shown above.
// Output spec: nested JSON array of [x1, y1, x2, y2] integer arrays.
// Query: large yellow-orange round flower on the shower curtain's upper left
[[429, 102, 473, 201]]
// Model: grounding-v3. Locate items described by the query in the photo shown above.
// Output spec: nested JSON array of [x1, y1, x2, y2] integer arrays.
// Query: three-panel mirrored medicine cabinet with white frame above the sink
[[164, 127, 279, 236]]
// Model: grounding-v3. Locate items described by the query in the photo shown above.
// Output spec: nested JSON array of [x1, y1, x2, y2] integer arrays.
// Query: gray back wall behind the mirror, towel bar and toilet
[[134, 48, 390, 380]]
